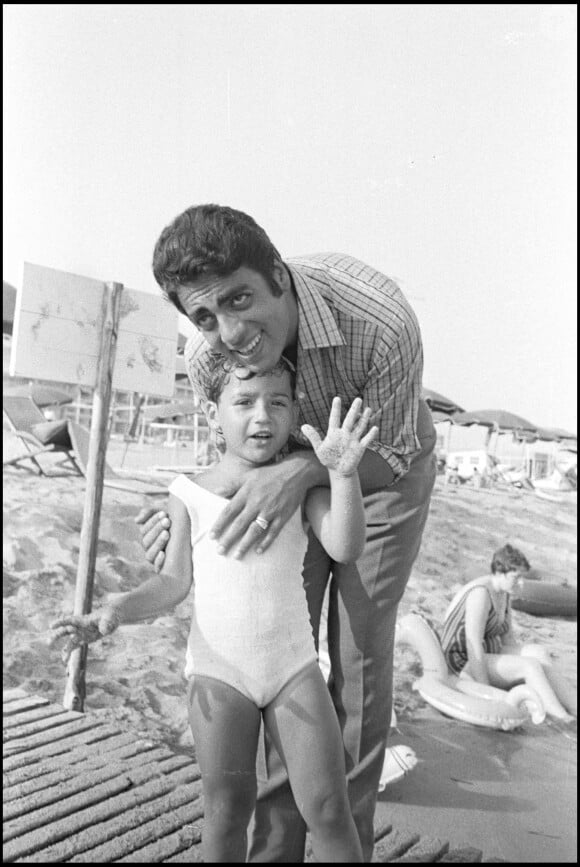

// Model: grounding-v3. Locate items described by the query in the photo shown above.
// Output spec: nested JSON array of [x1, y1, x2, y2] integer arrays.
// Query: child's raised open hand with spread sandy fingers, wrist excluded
[[301, 397, 379, 476]]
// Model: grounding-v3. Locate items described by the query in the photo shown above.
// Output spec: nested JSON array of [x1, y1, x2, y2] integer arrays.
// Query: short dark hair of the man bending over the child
[[152, 204, 282, 315]]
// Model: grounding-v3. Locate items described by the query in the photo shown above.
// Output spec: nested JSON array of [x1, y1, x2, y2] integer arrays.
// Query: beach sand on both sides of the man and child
[[3, 432, 577, 863]]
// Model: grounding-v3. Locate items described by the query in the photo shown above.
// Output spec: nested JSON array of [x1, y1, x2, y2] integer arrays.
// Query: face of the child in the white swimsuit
[[214, 371, 296, 464]]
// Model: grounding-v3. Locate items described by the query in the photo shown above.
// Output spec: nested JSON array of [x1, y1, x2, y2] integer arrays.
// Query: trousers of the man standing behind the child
[[248, 402, 436, 864]]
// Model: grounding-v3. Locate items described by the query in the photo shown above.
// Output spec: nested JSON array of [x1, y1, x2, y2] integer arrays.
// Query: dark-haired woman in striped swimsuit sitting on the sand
[[441, 545, 577, 721]]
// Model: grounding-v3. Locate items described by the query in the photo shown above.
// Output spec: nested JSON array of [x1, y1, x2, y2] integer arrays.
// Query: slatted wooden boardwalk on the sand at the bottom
[[3, 689, 490, 864]]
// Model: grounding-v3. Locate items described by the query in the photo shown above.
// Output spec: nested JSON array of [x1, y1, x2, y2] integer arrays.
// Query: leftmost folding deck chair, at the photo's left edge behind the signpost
[[2, 394, 83, 476]]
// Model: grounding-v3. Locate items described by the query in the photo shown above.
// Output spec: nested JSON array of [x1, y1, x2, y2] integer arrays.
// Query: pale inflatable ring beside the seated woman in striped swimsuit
[[396, 612, 546, 731]]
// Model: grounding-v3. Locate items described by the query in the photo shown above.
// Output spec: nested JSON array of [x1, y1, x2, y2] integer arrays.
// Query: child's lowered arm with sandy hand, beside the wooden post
[[51, 494, 193, 662]]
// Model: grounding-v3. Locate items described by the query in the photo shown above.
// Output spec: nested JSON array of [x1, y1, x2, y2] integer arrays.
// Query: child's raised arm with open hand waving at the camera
[[302, 397, 378, 563]]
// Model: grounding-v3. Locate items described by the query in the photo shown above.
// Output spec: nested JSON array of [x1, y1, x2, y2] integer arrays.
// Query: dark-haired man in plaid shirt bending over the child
[[137, 205, 436, 863]]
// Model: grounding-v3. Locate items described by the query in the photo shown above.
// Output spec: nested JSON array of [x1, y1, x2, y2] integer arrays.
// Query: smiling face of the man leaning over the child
[[178, 263, 298, 373]]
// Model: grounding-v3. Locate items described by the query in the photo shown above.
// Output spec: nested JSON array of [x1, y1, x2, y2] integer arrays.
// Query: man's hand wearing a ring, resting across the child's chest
[[211, 450, 320, 559]]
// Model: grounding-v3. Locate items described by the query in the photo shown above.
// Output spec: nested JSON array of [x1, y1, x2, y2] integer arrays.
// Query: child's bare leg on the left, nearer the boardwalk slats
[[189, 677, 261, 863]]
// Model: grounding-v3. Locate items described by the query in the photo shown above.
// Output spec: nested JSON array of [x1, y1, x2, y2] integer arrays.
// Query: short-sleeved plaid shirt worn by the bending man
[[184, 253, 423, 481]]
